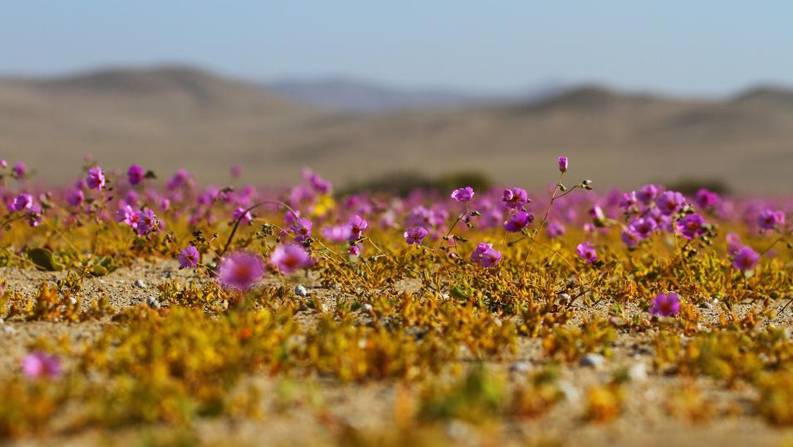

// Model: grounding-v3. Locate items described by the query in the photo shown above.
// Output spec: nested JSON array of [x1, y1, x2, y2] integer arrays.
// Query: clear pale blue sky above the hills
[[0, 0, 793, 94]]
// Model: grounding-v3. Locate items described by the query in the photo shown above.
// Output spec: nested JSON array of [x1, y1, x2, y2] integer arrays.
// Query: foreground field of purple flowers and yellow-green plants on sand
[[0, 156, 793, 445]]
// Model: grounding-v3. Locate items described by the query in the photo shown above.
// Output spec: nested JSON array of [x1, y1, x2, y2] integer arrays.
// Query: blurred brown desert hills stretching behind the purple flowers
[[0, 66, 793, 193]]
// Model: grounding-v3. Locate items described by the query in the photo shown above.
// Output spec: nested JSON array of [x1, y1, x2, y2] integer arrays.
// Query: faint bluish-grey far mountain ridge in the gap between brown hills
[[265, 78, 562, 113]]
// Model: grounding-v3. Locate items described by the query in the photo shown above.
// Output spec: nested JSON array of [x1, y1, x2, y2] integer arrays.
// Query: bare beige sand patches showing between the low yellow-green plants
[[0, 262, 793, 447]]
